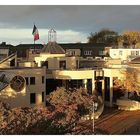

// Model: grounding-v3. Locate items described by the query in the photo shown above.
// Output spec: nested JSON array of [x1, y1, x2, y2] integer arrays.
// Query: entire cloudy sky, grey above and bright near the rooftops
[[0, 5, 140, 44]]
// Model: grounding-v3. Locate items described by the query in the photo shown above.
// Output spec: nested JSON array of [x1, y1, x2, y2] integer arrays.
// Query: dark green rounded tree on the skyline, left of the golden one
[[88, 29, 118, 45]]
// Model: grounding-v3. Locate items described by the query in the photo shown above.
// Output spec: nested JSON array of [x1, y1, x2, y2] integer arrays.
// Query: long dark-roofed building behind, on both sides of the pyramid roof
[[0, 43, 107, 58]]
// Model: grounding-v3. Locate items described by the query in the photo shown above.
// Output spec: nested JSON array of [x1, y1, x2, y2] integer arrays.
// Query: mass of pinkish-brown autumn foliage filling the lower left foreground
[[0, 88, 97, 134]]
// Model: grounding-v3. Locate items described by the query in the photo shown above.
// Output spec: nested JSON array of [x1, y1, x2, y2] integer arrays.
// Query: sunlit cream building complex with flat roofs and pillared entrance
[[0, 41, 140, 107]]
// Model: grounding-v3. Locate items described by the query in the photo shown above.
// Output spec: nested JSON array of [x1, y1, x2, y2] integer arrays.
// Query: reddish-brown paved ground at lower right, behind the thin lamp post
[[76, 109, 140, 135]]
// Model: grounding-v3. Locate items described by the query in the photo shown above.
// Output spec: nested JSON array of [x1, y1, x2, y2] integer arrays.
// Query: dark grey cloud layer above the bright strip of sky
[[0, 5, 140, 33]]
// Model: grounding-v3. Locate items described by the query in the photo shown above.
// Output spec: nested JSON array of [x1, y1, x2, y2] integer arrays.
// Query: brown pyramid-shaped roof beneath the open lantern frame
[[41, 42, 65, 54]]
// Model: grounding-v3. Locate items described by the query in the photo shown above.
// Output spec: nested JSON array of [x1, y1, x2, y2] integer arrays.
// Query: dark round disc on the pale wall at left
[[10, 75, 25, 92]]
